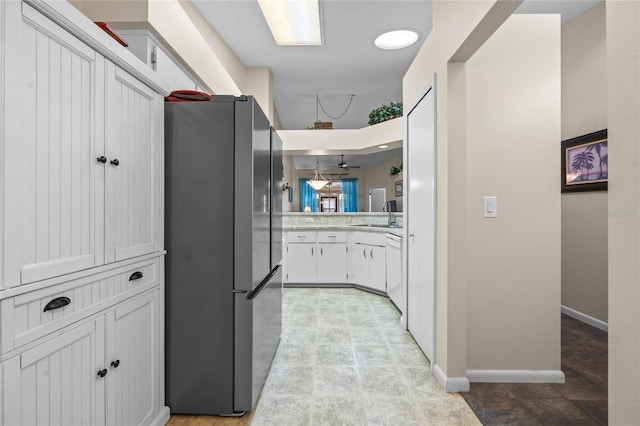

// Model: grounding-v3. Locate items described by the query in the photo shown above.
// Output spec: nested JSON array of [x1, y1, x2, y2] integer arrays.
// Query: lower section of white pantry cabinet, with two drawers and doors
[[0, 259, 164, 426]]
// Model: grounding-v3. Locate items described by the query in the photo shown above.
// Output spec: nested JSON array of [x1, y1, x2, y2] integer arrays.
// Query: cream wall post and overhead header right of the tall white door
[[402, 0, 520, 382]]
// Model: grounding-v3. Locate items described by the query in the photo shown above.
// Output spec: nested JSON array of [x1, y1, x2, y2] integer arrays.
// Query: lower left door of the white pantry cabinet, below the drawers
[[0, 317, 107, 425]]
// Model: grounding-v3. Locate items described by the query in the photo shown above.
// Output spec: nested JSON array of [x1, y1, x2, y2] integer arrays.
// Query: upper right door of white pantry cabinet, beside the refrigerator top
[[105, 62, 163, 262]]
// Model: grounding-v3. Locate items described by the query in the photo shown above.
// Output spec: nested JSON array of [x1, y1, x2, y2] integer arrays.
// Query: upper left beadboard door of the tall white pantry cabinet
[[4, 4, 104, 287]]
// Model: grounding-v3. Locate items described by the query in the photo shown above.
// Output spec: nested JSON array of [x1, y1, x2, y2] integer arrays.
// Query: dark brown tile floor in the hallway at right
[[462, 315, 608, 426]]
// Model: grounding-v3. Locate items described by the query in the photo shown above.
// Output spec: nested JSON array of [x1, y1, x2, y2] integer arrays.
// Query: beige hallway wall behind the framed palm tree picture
[[562, 2, 608, 322]]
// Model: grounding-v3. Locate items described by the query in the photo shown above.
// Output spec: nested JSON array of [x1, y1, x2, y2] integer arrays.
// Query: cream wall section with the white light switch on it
[[466, 15, 560, 372]]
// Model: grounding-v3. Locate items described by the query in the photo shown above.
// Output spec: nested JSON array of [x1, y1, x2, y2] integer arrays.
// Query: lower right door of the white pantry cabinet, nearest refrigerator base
[[105, 291, 160, 425]]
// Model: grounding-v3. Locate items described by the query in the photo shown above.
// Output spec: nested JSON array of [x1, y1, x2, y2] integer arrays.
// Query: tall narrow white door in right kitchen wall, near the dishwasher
[[405, 80, 435, 366]]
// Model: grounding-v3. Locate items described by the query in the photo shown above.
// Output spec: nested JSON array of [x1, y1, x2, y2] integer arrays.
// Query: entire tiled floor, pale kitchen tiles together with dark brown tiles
[[168, 288, 607, 426]]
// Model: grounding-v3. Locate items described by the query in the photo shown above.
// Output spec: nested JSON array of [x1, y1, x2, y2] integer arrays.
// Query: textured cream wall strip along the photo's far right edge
[[606, 1, 640, 425]]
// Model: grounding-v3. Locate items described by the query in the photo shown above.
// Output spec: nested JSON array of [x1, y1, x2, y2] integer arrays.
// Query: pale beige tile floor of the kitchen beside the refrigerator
[[248, 288, 480, 426]]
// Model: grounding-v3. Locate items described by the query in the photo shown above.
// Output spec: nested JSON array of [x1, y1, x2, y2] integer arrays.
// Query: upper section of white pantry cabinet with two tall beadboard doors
[[0, 1, 164, 289]]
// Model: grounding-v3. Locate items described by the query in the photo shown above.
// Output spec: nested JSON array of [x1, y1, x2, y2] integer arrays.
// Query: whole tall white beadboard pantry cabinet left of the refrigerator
[[0, 0, 169, 426]]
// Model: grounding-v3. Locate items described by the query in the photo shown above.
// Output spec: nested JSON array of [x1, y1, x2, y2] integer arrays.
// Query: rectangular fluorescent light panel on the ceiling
[[258, 0, 322, 46]]
